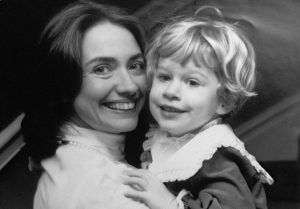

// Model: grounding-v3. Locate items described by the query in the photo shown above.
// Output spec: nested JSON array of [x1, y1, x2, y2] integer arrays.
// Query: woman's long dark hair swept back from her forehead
[[22, 1, 145, 163]]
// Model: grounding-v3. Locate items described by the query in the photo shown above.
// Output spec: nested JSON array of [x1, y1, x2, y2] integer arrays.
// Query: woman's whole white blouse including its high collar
[[34, 125, 148, 209]]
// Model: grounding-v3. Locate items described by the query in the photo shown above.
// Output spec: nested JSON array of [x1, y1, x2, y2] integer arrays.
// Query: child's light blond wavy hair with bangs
[[146, 8, 256, 116]]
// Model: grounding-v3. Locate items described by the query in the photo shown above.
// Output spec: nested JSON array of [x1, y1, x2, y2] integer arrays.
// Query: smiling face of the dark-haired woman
[[74, 22, 147, 133]]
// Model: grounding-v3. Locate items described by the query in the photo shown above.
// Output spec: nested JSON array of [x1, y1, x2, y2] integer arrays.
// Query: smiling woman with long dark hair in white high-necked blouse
[[22, 1, 147, 209]]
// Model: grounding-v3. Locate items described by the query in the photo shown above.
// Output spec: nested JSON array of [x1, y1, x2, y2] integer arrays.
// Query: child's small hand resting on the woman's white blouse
[[124, 169, 177, 209]]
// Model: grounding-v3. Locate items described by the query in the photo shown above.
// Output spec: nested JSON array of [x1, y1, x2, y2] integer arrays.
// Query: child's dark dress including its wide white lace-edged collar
[[144, 121, 273, 209]]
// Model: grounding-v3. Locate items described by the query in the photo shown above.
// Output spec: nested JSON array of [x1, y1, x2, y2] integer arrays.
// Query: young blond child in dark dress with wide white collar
[[125, 9, 273, 209]]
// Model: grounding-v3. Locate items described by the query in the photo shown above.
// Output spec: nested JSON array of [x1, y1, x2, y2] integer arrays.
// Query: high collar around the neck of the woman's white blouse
[[62, 123, 125, 162]]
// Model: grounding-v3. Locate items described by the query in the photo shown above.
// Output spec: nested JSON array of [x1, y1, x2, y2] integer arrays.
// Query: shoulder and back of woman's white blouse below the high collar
[[35, 149, 146, 209]]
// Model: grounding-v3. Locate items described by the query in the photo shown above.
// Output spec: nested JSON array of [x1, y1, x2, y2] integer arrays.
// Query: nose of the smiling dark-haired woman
[[117, 70, 139, 96]]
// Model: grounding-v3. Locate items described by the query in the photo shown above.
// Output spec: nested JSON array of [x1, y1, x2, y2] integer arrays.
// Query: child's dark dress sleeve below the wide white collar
[[183, 149, 267, 209]]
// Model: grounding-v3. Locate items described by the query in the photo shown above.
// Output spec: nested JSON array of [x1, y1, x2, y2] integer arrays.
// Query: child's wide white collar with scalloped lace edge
[[144, 124, 273, 184]]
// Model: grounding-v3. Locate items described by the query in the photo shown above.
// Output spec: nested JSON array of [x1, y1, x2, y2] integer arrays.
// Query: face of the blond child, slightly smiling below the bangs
[[149, 58, 222, 136]]
